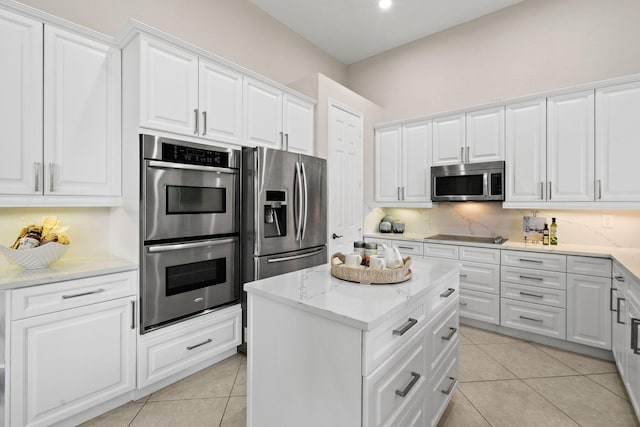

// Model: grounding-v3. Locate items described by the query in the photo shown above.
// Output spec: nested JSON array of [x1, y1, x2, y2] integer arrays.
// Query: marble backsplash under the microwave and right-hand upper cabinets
[[364, 202, 640, 248]]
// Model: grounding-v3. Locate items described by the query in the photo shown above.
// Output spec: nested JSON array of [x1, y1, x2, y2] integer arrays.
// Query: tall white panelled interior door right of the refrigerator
[[327, 103, 363, 255]]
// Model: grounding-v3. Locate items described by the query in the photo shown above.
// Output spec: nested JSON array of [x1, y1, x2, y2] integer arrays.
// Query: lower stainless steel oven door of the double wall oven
[[141, 237, 240, 333]]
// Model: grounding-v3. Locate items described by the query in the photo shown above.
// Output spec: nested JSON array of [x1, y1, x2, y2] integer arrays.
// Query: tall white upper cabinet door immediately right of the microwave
[[505, 99, 547, 202]]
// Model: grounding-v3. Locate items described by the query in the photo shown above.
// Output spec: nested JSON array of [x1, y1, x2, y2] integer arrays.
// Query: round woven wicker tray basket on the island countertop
[[331, 252, 411, 285]]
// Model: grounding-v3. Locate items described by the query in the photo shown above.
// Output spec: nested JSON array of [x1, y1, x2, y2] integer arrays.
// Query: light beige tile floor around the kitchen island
[[83, 325, 640, 427]]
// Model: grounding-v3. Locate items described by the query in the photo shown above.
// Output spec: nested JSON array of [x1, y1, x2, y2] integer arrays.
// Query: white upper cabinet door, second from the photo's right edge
[[546, 90, 595, 202]]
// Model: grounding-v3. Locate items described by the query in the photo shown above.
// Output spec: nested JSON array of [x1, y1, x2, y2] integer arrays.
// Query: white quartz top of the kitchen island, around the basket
[[244, 258, 460, 331]]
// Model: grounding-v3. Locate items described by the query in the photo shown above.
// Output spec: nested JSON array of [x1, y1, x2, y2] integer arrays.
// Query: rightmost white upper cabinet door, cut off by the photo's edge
[[595, 82, 640, 202]]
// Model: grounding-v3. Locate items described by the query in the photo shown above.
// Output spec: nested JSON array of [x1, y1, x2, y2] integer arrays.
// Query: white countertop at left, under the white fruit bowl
[[0, 256, 138, 291]]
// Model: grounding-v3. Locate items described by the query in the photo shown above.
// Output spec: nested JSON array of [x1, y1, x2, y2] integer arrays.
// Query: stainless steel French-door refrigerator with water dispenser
[[241, 147, 328, 344]]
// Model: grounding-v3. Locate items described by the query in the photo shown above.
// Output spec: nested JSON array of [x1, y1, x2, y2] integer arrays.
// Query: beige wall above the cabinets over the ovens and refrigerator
[[13, 0, 346, 84]]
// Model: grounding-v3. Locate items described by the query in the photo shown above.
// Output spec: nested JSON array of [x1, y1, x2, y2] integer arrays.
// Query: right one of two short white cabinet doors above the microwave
[[465, 106, 505, 163]]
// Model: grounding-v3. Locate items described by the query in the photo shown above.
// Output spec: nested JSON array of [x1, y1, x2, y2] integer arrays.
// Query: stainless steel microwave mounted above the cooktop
[[431, 161, 504, 202]]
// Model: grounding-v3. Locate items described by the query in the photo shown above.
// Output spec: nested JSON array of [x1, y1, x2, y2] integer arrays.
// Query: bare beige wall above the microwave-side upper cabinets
[[348, 0, 640, 121]]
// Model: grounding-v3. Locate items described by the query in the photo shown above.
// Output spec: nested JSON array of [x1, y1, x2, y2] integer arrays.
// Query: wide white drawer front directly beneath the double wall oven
[[138, 304, 242, 388]]
